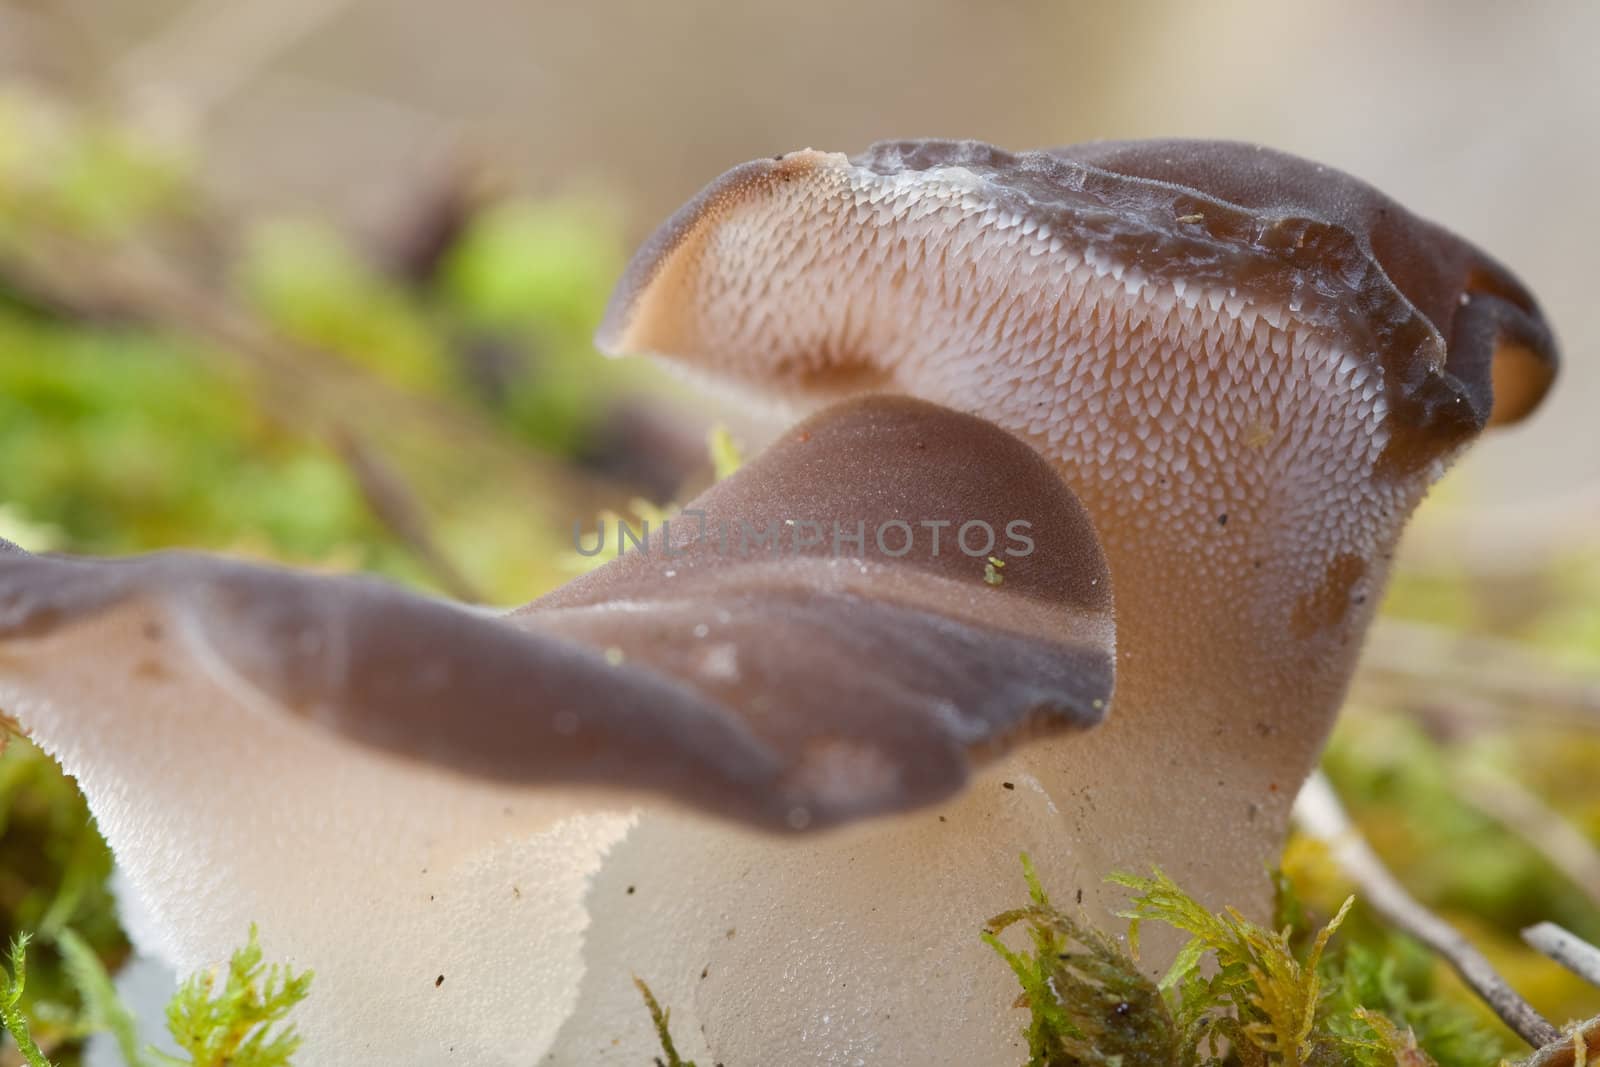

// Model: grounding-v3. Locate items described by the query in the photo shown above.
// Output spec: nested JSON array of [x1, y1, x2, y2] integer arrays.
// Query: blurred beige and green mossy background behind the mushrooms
[[0, 0, 1600, 1064]]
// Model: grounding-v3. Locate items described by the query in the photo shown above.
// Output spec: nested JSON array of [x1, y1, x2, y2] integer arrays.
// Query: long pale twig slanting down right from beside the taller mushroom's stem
[[1294, 771, 1562, 1048]]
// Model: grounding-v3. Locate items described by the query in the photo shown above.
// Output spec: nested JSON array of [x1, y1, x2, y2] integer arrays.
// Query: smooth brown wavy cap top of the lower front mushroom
[[0, 397, 1112, 830]]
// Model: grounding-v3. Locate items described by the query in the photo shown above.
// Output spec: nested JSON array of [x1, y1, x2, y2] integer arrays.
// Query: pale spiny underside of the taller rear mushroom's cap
[[603, 154, 1437, 591]]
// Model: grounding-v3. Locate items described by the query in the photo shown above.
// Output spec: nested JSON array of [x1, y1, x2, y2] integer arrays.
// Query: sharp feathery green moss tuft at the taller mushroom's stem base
[[982, 856, 1499, 1067]]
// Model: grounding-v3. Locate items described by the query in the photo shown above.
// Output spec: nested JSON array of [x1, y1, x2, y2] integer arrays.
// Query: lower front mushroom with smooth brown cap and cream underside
[[0, 397, 1114, 1067]]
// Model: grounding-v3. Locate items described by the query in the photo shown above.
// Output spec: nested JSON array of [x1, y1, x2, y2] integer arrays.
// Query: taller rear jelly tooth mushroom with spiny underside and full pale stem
[[537, 142, 1536, 1067]]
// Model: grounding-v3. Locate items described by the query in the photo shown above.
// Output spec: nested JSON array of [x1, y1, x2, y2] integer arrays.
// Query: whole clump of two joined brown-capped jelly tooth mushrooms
[[0, 142, 1555, 1067]]
